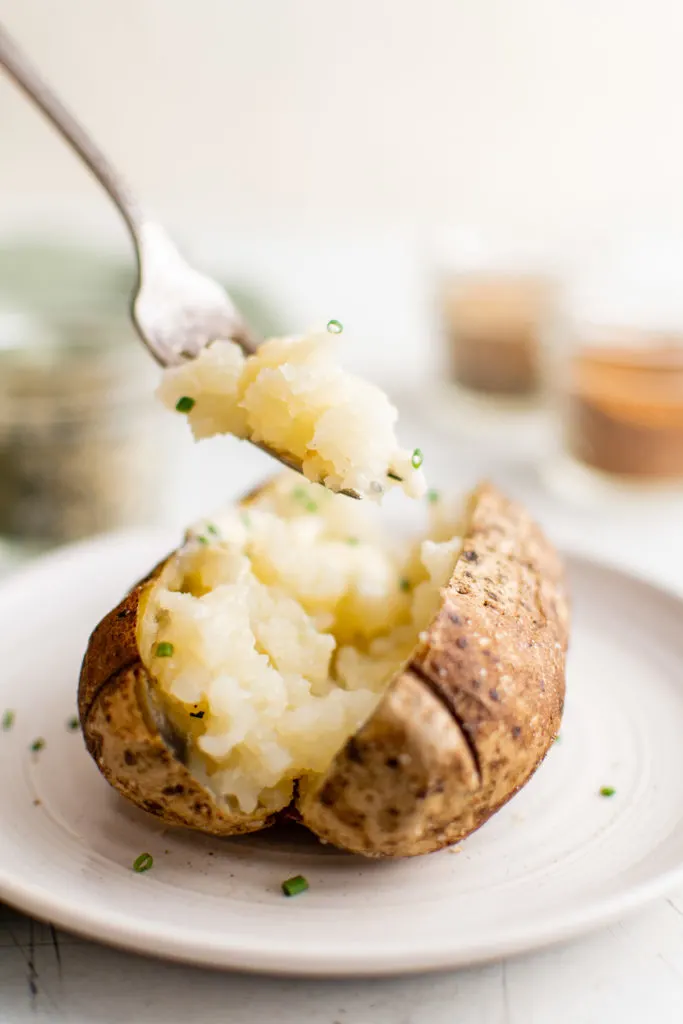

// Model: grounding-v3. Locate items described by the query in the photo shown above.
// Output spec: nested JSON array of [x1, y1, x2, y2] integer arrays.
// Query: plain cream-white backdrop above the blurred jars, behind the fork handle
[[0, 0, 683, 239]]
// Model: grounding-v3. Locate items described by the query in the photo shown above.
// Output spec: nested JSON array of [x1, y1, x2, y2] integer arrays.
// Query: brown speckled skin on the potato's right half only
[[300, 483, 569, 857]]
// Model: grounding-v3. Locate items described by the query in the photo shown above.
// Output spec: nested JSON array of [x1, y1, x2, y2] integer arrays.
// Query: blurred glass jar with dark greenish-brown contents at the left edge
[[0, 317, 167, 547]]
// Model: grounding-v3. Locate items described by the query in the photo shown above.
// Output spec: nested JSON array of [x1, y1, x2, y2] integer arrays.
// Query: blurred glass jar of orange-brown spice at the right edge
[[547, 235, 683, 499]]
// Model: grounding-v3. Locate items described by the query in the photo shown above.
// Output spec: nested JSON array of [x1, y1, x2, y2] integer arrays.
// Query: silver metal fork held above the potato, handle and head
[[0, 25, 360, 498]]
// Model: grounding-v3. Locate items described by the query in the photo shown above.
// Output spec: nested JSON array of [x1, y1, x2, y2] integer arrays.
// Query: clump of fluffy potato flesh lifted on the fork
[[159, 332, 426, 500]]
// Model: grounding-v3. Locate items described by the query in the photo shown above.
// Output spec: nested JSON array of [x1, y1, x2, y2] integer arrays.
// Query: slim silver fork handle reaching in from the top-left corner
[[0, 25, 146, 240]]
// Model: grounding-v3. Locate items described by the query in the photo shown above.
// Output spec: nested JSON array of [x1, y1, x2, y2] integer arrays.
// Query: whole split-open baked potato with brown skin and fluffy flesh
[[79, 473, 568, 857]]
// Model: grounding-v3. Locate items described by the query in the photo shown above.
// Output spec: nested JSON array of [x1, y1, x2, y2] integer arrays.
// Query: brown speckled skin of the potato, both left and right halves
[[79, 483, 569, 857]]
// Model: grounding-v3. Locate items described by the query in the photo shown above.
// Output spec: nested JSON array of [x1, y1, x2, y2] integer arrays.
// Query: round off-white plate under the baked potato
[[0, 534, 683, 975]]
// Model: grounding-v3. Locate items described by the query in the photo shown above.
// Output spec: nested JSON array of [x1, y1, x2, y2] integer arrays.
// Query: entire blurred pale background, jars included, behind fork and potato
[[0, 0, 683, 573]]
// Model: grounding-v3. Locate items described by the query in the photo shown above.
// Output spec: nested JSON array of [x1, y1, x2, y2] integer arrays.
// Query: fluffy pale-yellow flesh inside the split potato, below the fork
[[138, 471, 461, 813]]
